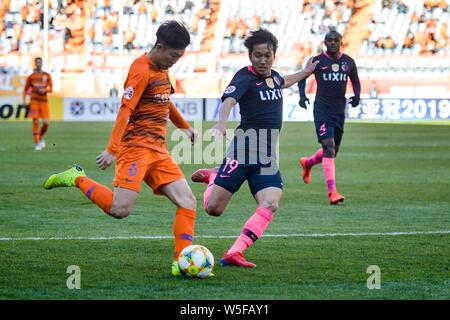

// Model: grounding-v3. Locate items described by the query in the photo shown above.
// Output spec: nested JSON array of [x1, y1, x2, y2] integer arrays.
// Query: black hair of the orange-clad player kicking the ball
[[155, 20, 191, 49]]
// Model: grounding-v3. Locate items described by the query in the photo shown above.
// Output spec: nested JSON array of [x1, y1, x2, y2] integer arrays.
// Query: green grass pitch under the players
[[0, 122, 450, 300]]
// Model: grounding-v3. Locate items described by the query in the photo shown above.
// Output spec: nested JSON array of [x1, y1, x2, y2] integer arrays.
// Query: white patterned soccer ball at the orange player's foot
[[178, 244, 214, 278]]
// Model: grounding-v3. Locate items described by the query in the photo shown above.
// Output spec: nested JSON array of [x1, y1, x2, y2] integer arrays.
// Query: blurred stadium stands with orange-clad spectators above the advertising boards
[[0, 0, 450, 95]]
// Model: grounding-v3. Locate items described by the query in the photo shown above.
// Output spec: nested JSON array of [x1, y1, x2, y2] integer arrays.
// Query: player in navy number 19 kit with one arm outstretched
[[192, 29, 318, 268]]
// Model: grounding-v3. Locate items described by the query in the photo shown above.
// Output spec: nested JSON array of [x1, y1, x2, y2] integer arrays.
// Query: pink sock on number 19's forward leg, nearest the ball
[[228, 207, 273, 253]]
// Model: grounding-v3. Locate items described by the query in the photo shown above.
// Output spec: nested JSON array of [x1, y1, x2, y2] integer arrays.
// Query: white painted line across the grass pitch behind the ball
[[0, 230, 450, 241]]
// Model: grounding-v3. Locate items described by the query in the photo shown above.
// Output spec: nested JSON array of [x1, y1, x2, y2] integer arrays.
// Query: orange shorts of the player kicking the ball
[[113, 146, 184, 194]]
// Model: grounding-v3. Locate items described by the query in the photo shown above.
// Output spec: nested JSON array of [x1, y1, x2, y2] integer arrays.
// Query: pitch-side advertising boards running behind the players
[[0, 96, 450, 121]]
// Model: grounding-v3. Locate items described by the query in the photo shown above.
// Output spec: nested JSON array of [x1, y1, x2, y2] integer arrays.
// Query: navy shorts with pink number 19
[[214, 158, 283, 196]]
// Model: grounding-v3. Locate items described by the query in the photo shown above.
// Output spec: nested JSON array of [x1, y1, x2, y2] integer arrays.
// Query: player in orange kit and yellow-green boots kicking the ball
[[44, 21, 197, 275]]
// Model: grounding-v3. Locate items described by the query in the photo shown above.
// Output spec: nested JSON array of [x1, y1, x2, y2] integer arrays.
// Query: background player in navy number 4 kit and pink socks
[[298, 31, 361, 205]]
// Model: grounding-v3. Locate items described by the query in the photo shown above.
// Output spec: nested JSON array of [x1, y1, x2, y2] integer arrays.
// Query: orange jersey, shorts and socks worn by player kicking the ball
[[75, 55, 195, 258]]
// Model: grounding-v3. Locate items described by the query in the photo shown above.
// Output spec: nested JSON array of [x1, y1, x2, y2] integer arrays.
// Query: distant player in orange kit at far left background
[[23, 58, 53, 151]]
